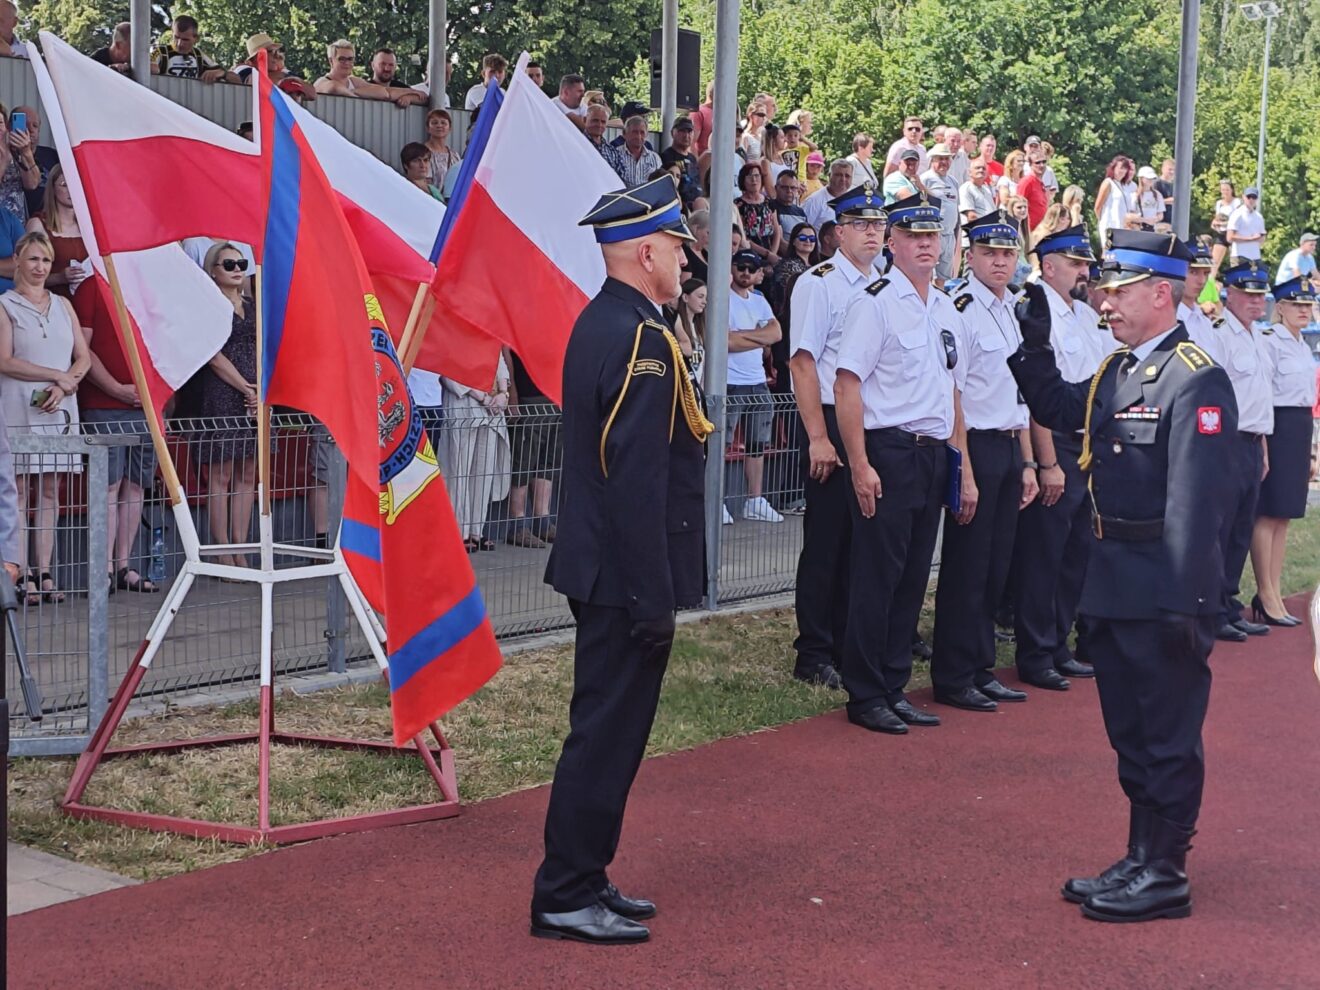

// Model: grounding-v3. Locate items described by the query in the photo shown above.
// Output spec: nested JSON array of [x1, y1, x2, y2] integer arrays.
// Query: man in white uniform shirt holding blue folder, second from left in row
[[834, 195, 962, 734]]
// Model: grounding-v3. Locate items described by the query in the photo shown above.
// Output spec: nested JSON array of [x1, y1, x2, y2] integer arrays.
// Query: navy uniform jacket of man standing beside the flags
[[545, 279, 705, 622]]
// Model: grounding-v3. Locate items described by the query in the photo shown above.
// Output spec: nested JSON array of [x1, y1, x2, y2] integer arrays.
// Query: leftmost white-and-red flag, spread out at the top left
[[41, 32, 265, 253]]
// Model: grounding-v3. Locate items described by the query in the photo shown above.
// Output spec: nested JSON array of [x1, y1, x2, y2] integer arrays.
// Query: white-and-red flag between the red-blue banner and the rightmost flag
[[279, 91, 499, 391]]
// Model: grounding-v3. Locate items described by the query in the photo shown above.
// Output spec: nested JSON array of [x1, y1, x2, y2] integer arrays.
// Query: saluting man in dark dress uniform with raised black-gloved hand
[[1008, 231, 1238, 921]]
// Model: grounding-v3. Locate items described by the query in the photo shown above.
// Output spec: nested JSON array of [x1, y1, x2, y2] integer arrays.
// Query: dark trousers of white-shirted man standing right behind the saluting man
[[1014, 433, 1096, 675]]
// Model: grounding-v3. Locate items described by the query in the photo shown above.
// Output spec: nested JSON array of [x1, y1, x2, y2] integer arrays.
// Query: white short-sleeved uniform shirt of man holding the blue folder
[[837, 267, 955, 440]]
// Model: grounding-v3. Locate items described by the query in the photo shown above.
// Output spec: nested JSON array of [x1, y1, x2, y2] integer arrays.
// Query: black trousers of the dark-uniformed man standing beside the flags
[[532, 601, 671, 912]]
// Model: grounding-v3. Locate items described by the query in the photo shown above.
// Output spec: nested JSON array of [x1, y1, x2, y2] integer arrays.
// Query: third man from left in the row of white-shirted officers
[[931, 210, 1038, 711]]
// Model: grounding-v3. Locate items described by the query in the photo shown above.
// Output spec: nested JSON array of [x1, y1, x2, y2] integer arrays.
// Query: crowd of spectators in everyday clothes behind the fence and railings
[[0, 23, 1317, 609]]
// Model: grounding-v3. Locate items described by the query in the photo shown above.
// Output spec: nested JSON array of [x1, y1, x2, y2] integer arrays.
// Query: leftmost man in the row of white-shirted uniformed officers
[[788, 183, 886, 688]]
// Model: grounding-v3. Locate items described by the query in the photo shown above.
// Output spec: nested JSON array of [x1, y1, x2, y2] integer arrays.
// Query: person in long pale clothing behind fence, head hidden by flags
[[441, 356, 513, 553]]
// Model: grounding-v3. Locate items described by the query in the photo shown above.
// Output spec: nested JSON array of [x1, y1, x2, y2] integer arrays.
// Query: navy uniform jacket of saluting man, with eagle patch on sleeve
[[1008, 323, 1237, 619]]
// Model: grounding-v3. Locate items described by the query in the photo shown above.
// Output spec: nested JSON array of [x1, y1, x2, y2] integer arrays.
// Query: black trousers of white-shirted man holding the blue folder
[[840, 430, 949, 713]]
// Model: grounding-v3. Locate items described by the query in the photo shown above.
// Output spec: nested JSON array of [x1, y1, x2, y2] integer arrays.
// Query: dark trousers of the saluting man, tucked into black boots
[[1086, 614, 1217, 826]]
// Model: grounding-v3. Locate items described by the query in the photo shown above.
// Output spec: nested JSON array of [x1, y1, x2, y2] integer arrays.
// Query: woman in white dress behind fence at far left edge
[[0, 231, 91, 605]]
